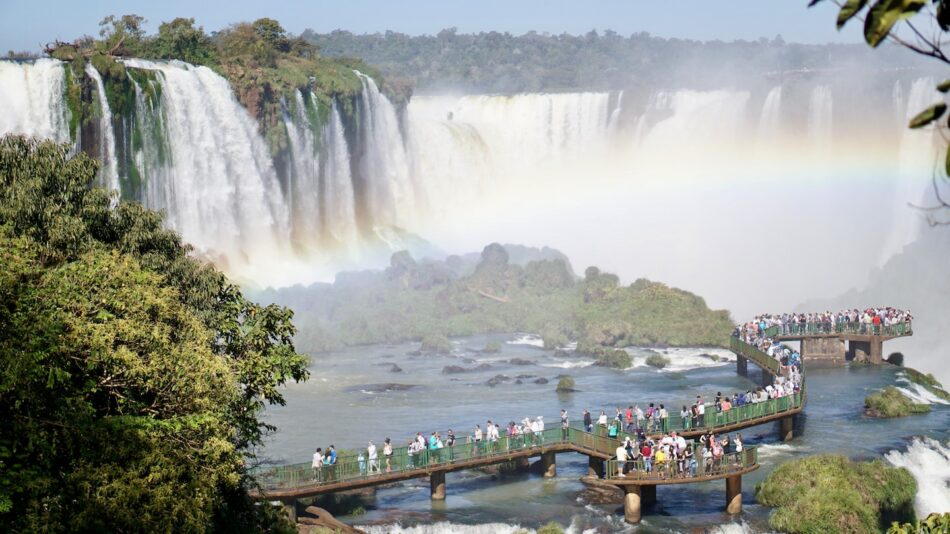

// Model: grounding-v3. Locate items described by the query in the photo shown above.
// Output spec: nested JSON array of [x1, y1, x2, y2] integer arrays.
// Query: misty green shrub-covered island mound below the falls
[[255, 244, 733, 351]]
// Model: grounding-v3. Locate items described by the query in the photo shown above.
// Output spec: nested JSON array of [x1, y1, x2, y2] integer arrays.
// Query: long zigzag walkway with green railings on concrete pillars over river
[[251, 316, 864, 522]]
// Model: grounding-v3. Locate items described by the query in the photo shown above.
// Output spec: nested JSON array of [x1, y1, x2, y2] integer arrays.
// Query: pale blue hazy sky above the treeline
[[0, 0, 861, 52]]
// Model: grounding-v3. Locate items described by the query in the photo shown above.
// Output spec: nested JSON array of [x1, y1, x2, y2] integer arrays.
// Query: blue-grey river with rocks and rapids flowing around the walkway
[[262, 334, 950, 534]]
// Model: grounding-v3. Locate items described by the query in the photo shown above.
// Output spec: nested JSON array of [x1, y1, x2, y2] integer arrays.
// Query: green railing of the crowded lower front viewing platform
[[604, 447, 759, 482]]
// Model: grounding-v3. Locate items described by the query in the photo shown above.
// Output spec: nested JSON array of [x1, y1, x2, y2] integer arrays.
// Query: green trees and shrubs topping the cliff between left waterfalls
[[46, 15, 402, 154]]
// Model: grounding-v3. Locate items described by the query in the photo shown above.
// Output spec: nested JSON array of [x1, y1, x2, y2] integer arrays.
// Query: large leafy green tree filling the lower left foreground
[[0, 137, 307, 532]]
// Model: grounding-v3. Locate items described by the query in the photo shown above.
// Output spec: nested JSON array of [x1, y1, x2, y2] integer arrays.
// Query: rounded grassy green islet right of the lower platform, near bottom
[[755, 454, 917, 534]]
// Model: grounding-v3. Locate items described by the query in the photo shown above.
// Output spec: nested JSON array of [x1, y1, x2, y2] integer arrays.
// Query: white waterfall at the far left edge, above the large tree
[[0, 59, 69, 143]]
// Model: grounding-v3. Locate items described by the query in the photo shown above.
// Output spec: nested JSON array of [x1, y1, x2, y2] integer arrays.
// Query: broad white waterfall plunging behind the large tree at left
[[125, 60, 291, 279]]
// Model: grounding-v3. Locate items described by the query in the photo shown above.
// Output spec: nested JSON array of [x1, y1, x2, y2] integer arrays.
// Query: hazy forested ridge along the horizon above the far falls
[[301, 28, 935, 94]]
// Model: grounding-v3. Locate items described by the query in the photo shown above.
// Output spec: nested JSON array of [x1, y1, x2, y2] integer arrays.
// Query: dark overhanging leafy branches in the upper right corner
[[808, 0, 950, 225]]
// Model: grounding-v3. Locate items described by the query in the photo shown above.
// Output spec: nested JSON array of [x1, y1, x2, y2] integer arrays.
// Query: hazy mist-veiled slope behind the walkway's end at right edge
[[800, 227, 950, 383]]
